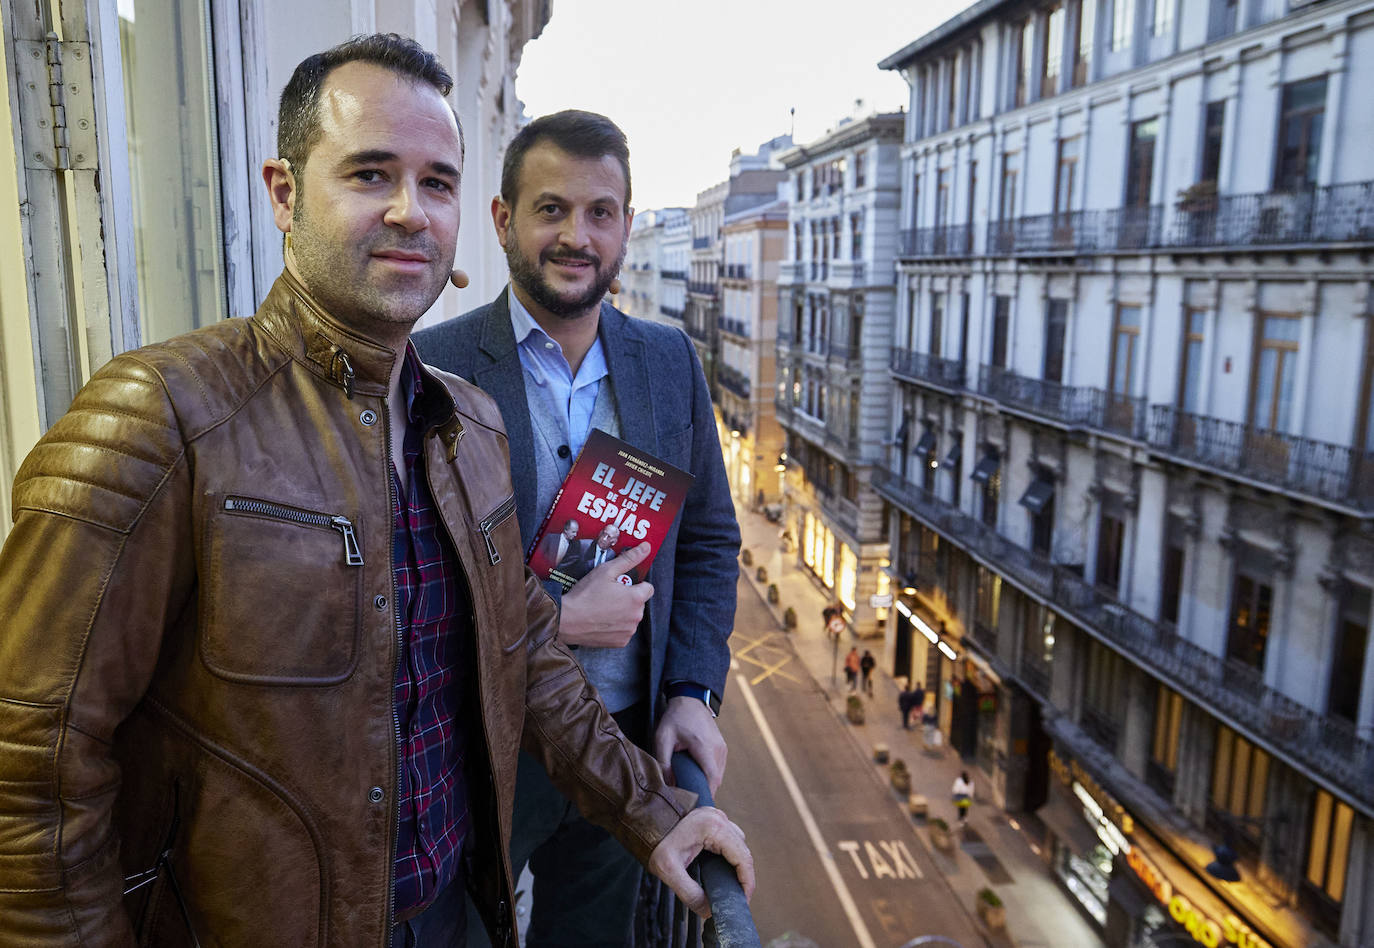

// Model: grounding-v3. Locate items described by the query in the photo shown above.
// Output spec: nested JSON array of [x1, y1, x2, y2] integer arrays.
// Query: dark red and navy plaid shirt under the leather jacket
[[392, 345, 471, 912]]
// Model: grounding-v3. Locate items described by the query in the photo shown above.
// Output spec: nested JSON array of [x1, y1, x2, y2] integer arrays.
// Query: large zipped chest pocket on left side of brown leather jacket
[[199, 496, 363, 684]]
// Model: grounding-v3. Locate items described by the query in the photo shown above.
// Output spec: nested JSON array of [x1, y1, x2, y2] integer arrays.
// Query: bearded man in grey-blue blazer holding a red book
[[414, 111, 739, 948]]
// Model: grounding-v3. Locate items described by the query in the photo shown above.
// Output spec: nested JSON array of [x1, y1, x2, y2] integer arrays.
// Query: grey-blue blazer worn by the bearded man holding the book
[[412, 290, 739, 720]]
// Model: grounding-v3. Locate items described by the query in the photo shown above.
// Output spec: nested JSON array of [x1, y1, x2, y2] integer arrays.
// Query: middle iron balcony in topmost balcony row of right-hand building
[[988, 205, 1164, 254]]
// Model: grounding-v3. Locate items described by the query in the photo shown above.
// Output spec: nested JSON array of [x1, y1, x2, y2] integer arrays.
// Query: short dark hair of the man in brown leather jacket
[[276, 33, 466, 177]]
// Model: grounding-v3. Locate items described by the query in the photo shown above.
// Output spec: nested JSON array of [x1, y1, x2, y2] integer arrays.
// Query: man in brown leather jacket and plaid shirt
[[0, 36, 753, 948]]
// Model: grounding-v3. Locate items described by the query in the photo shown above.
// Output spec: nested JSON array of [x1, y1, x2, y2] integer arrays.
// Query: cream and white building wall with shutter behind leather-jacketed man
[[0, 0, 552, 536]]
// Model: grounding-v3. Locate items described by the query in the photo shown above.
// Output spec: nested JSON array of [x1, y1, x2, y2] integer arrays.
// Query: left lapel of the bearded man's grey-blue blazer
[[473, 287, 540, 538]]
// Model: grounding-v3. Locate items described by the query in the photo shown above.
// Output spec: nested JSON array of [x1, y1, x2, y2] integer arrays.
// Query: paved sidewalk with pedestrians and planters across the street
[[736, 497, 1103, 948]]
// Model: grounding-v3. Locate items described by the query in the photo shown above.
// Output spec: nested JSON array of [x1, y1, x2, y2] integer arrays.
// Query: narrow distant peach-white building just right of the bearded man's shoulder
[[716, 193, 787, 508]]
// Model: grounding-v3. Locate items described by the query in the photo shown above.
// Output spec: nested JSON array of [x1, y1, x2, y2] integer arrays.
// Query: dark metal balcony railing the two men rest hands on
[[633, 750, 760, 948]]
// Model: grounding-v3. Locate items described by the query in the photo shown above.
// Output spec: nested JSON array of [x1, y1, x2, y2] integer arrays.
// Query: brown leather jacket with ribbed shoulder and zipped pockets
[[0, 275, 690, 947]]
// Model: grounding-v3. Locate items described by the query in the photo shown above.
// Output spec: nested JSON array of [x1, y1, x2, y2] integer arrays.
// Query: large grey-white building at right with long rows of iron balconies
[[872, 0, 1374, 948]]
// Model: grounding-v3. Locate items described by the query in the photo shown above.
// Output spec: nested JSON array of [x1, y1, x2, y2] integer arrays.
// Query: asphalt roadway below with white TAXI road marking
[[717, 568, 985, 948]]
